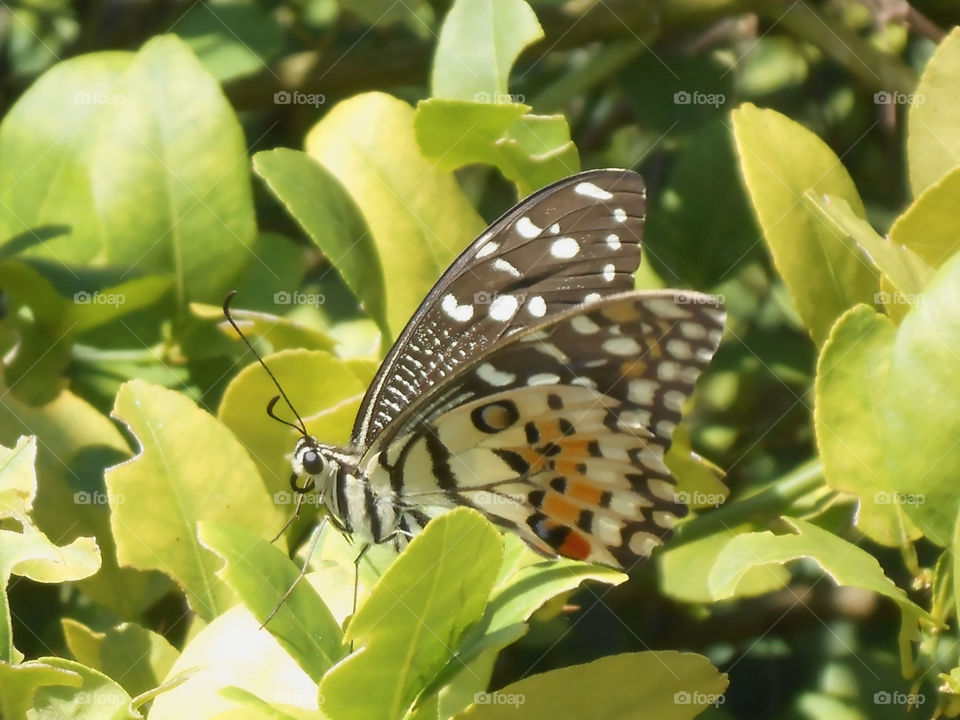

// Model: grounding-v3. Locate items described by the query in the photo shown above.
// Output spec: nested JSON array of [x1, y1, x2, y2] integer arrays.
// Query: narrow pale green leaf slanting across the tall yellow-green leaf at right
[[803, 191, 933, 298]]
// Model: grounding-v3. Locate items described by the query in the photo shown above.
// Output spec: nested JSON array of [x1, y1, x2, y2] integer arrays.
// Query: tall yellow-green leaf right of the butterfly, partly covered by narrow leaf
[[733, 103, 877, 345]]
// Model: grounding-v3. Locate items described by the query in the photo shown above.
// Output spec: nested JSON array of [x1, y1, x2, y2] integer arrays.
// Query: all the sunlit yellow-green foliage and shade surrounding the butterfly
[[0, 0, 960, 720]]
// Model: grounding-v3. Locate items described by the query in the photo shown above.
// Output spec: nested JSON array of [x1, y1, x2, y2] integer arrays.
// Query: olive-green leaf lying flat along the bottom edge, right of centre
[[455, 650, 727, 720]]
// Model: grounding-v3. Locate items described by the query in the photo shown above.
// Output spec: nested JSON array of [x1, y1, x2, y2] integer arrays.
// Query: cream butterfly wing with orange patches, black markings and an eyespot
[[363, 291, 724, 568]]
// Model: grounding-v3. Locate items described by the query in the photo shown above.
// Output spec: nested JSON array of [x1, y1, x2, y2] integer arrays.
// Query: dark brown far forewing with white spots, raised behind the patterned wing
[[352, 170, 646, 448]]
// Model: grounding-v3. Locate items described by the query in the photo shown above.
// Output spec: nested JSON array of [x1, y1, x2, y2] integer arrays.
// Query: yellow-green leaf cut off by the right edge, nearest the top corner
[[907, 28, 960, 197]]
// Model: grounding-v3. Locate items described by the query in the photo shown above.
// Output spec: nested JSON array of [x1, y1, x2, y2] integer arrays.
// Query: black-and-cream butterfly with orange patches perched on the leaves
[[246, 170, 725, 568]]
